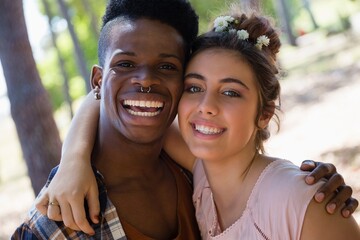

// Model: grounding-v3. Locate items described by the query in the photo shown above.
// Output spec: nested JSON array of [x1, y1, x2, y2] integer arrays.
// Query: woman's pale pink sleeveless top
[[193, 159, 323, 240]]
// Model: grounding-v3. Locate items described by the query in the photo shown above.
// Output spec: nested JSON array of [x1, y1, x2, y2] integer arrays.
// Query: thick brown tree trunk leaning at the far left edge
[[0, 0, 61, 194]]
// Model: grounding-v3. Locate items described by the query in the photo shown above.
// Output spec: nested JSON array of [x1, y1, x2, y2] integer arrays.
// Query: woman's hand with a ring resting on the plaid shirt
[[35, 160, 100, 235]]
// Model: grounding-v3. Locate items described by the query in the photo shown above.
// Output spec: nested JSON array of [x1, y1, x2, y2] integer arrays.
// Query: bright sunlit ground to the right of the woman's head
[[266, 31, 360, 223]]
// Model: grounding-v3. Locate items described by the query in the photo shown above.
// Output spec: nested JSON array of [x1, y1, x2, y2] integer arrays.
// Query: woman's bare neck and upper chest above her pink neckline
[[203, 151, 265, 230]]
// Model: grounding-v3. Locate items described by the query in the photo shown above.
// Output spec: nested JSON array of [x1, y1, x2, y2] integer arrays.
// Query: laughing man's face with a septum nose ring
[[94, 19, 185, 142]]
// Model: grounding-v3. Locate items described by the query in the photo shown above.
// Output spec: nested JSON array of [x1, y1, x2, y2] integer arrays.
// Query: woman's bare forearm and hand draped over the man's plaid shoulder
[[36, 93, 100, 234]]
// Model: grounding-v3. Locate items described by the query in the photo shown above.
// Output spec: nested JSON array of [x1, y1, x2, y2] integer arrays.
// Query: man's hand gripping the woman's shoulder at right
[[300, 160, 359, 218]]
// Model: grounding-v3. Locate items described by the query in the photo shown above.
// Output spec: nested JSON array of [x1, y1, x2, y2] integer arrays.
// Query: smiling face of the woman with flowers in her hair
[[178, 49, 264, 160]]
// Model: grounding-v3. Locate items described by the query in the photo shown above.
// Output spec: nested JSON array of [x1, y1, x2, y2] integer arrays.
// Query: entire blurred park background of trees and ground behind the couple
[[0, 0, 360, 237]]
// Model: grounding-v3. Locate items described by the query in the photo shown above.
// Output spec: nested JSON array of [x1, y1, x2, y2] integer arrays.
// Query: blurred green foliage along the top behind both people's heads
[[34, 0, 359, 108]]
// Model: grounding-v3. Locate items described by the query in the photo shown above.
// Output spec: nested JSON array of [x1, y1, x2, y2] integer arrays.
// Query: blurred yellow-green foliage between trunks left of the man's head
[[37, 0, 106, 110]]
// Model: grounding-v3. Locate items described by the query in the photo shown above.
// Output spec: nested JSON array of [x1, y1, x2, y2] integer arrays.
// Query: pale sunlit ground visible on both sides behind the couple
[[0, 30, 360, 239]]
